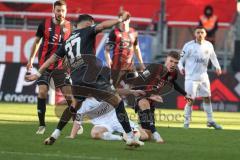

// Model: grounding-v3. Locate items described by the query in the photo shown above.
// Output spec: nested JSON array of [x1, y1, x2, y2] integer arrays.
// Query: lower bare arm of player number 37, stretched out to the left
[[25, 54, 58, 81]]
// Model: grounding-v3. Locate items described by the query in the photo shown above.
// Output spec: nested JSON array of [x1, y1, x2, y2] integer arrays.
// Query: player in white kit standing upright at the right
[[178, 27, 222, 129]]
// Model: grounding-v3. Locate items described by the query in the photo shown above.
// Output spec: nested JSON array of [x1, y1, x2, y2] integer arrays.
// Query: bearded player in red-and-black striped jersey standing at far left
[[27, 0, 71, 134]]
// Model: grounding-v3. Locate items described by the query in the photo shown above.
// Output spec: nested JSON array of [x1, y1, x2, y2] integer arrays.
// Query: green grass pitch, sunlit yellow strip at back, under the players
[[0, 103, 240, 160]]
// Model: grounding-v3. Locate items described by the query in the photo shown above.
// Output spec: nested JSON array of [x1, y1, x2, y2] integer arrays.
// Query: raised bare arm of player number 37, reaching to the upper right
[[96, 11, 130, 32]]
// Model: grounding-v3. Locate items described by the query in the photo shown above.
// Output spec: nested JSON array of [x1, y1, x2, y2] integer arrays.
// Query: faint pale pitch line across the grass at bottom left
[[0, 151, 118, 160]]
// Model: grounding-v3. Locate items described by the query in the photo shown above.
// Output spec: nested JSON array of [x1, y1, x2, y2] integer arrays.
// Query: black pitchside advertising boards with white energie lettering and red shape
[[0, 62, 240, 112]]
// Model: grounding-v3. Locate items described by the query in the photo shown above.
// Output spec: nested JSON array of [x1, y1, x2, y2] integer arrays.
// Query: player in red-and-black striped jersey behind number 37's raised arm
[[105, 14, 145, 87]]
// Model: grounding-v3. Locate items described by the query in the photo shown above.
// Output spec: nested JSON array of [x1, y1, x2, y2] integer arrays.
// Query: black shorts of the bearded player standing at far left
[[37, 70, 67, 88]]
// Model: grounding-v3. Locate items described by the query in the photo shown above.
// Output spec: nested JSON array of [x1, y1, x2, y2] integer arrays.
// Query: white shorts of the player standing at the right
[[185, 78, 211, 98]]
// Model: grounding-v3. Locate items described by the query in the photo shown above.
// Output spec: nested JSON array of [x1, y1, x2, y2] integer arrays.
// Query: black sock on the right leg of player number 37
[[115, 101, 132, 133]]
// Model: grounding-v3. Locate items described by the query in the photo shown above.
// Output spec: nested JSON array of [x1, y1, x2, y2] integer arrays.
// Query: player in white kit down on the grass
[[69, 97, 148, 140]]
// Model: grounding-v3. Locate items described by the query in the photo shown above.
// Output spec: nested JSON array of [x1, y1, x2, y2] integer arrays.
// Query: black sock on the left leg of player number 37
[[57, 106, 77, 131]]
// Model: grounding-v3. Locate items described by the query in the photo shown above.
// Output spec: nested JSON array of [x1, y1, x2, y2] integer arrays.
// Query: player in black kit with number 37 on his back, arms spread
[[26, 12, 144, 146]]
